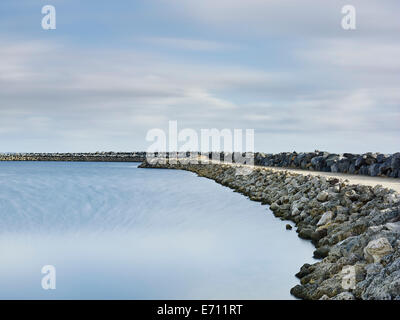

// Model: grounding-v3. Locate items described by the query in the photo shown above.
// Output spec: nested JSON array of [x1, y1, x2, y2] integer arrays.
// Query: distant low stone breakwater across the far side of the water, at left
[[0, 152, 146, 162]]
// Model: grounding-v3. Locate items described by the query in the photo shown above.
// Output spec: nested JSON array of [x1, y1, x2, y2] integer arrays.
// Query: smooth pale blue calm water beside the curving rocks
[[0, 162, 313, 299]]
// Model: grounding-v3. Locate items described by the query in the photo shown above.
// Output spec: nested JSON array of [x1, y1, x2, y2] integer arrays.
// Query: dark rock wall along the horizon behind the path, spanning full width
[[0, 150, 400, 178]]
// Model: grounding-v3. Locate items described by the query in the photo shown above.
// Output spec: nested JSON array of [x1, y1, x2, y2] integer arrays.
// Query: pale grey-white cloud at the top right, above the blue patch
[[164, 0, 400, 38]]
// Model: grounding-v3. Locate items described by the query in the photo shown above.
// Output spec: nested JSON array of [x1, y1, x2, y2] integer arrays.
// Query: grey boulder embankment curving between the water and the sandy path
[[140, 158, 400, 300]]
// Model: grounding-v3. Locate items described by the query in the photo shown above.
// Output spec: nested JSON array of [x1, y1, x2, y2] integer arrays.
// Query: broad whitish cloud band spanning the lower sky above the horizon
[[0, 35, 399, 151]]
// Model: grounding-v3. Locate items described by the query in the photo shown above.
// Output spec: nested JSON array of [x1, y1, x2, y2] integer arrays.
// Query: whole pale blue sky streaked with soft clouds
[[0, 0, 400, 153]]
